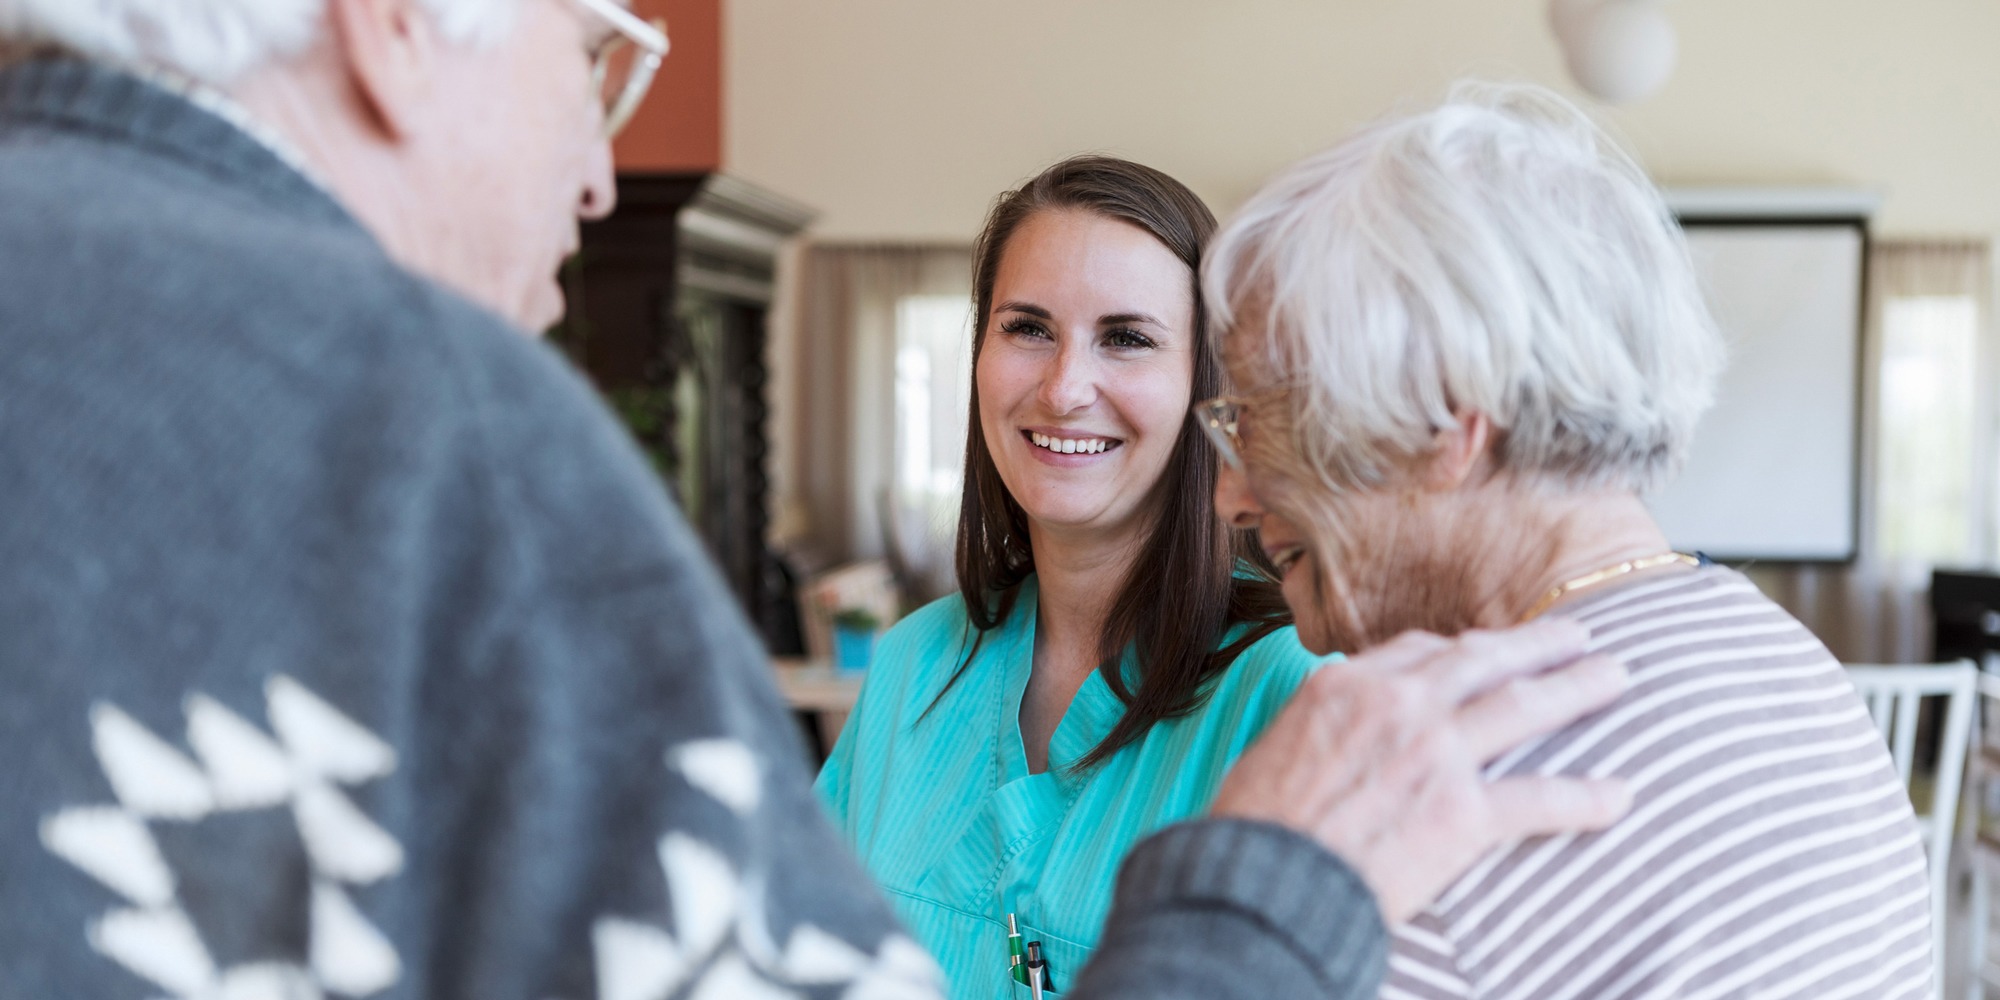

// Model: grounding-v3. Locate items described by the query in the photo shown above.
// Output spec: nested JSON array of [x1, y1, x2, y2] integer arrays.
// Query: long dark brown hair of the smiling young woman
[[926, 156, 1292, 770]]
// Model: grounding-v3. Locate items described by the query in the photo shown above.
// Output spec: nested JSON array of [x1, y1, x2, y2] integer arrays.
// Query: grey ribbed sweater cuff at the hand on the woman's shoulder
[[1068, 820, 1388, 1000]]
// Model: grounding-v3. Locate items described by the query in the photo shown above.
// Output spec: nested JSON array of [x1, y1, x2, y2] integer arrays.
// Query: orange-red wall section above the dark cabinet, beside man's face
[[614, 0, 722, 174]]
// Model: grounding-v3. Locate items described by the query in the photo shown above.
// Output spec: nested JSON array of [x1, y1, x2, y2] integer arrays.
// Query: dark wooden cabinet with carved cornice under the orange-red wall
[[552, 174, 812, 652]]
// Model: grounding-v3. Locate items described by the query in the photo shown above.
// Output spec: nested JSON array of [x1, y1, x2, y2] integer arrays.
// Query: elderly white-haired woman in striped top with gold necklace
[[1196, 88, 1932, 1000]]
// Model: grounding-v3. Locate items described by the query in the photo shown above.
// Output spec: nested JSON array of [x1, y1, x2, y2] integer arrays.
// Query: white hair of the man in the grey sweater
[[0, 0, 518, 86]]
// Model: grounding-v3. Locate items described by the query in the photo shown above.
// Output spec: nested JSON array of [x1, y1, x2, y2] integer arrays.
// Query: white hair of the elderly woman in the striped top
[[1204, 84, 1724, 492]]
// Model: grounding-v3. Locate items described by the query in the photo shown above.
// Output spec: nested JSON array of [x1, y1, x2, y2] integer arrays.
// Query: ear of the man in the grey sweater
[[326, 0, 438, 140]]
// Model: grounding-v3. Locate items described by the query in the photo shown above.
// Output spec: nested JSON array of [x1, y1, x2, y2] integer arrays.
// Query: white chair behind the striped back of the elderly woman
[[1848, 660, 1980, 994]]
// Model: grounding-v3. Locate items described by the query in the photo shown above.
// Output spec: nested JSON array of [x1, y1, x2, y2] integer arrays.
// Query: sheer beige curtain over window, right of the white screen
[[1750, 240, 2000, 662]]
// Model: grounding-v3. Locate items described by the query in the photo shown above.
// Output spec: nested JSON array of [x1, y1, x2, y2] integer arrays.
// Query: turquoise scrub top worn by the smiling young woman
[[816, 578, 1320, 1000]]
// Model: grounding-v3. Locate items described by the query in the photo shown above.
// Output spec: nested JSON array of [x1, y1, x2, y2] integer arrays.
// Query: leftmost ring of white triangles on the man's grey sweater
[[40, 676, 404, 1000]]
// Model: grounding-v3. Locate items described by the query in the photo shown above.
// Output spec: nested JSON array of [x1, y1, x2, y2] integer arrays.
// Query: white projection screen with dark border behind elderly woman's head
[[1648, 220, 1868, 562]]
